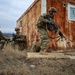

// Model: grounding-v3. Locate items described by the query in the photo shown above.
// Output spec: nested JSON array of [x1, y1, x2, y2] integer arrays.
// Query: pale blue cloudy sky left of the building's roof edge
[[0, 0, 34, 33]]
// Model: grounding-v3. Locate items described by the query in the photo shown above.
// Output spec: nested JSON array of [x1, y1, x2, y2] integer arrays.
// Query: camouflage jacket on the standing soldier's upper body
[[36, 13, 58, 30]]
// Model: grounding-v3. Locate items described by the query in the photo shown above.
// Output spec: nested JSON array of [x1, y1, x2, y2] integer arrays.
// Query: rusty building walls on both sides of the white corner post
[[17, 0, 75, 50]]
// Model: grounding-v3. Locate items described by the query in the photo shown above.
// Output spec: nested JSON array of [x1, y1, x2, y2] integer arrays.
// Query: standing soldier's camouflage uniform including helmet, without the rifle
[[36, 8, 58, 51]]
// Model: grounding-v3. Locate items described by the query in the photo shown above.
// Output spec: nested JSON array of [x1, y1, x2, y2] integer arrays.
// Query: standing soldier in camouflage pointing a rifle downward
[[36, 7, 64, 51]]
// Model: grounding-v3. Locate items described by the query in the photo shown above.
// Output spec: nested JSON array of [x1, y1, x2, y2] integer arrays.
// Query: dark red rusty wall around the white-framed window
[[47, 0, 75, 49]]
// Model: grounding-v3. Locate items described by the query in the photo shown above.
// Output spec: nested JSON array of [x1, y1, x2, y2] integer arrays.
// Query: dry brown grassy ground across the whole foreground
[[0, 44, 75, 75]]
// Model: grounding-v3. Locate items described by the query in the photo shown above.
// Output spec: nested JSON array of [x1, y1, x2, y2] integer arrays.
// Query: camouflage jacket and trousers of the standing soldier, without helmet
[[36, 14, 51, 51]]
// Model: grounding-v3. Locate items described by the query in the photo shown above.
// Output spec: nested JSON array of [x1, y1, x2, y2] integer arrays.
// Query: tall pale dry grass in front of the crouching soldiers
[[2, 43, 27, 60]]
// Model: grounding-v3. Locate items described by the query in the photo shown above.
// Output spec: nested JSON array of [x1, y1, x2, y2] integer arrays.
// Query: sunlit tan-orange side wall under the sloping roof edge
[[17, 0, 41, 46]]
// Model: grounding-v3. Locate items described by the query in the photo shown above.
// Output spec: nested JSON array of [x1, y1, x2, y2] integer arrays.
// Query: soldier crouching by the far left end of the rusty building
[[13, 28, 27, 50]]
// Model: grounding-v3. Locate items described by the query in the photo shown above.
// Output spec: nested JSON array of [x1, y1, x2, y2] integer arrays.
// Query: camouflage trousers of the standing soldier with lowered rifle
[[37, 28, 50, 50]]
